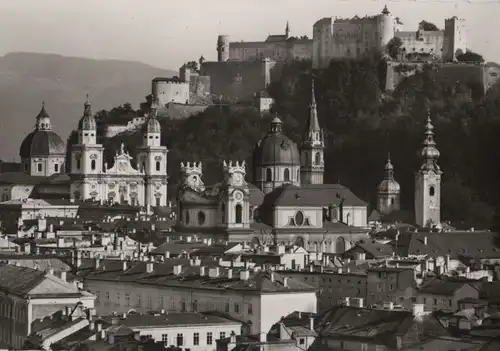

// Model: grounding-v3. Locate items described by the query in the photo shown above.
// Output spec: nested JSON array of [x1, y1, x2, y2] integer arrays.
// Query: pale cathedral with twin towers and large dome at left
[[0, 98, 168, 206]]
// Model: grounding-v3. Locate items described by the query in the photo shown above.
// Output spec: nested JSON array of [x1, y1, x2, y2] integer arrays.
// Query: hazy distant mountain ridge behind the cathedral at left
[[0, 52, 176, 161]]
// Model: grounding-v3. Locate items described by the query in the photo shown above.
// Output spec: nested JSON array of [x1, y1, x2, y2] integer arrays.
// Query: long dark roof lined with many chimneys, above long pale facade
[[85, 259, 316, 293]]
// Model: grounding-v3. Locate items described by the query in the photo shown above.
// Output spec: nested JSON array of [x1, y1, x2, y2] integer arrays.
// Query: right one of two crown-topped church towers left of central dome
[[220, 161, 250, 228]]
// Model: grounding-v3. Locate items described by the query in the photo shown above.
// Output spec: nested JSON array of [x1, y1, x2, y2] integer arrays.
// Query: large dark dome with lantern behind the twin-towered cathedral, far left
[[19, 103, 66, 159]]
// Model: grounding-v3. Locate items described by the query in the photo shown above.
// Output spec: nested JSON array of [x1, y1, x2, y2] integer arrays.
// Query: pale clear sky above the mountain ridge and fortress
[[0, 0, 500, 70]]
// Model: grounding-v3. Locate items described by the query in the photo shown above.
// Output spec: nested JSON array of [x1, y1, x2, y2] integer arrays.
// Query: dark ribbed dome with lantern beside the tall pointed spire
[[253, 116, 300, 166]]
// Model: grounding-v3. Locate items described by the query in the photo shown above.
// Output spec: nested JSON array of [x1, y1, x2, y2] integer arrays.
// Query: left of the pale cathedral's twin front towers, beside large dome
[[70, 95, 104, 200]]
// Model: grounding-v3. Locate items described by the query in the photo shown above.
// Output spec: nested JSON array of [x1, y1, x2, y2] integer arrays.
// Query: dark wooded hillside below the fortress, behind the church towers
[[68, 57, 500, 229]]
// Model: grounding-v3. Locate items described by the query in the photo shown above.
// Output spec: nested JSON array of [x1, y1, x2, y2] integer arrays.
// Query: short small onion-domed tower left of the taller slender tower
[[377, 154, 400, 215]]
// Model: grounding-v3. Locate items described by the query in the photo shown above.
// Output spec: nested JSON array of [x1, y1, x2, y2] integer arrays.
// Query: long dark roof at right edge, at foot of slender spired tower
[[395, 231, 500, 259]]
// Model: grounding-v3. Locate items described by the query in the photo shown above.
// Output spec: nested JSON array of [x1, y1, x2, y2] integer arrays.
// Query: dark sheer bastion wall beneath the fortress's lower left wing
[[201, 61, 284, 100]]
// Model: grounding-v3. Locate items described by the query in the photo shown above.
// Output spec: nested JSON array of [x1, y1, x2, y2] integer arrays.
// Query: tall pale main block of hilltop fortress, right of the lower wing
[[312, 6, 467, 68]]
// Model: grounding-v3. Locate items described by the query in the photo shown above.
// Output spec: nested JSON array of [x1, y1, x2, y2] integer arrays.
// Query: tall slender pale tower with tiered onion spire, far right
[[415, 115, 443, 227]]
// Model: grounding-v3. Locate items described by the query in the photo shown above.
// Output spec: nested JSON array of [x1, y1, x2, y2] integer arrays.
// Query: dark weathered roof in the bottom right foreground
[[317, 306, 448, 347]]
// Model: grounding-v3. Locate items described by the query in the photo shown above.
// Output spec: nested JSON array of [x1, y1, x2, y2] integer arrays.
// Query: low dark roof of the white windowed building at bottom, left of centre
[[102, 312, 237, 328]]
